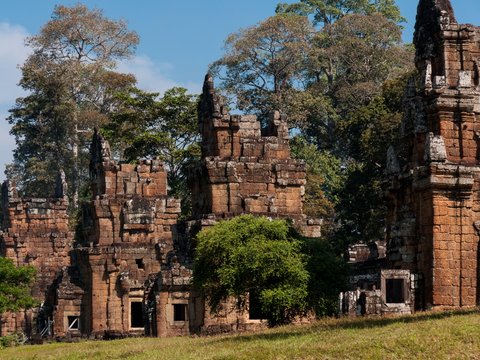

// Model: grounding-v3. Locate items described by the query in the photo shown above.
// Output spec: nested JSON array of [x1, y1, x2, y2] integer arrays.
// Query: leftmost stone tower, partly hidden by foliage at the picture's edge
[[0, 177, 73, 335]]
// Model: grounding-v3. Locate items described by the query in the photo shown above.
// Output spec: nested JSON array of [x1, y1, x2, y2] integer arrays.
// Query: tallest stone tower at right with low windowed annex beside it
[[341, 0, 480, 314]]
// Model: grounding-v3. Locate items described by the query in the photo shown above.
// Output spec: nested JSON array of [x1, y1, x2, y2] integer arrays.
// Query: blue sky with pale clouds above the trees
[[0, 0, 480, 179]]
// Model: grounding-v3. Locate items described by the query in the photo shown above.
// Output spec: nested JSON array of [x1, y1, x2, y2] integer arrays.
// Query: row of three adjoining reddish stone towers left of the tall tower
[[0, 76, 321, 338]]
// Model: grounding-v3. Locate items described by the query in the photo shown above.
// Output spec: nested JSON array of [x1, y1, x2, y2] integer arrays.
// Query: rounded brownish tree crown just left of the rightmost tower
[[295, 14, 413, 152]]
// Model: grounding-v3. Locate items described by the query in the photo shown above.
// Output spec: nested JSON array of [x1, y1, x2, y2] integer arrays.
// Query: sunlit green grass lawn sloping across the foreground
[[0, 311, 480, 360]]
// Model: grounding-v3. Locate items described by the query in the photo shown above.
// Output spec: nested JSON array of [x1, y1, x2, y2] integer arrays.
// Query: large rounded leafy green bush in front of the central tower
[[193, 215, 348, 325]]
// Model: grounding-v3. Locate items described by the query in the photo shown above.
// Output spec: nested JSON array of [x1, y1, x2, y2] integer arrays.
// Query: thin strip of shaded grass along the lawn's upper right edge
[[216, 309, 480, 343]]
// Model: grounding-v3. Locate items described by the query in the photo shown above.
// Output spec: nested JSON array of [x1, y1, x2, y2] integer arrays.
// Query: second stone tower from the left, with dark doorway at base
[[76, 134, 184, 336]]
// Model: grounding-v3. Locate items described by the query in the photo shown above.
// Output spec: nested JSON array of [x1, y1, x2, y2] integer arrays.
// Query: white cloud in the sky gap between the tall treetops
[[118, 55, 201, 94]]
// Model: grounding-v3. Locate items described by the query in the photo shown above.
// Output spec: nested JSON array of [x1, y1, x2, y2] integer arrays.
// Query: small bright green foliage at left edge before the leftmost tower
[[0, 257, 37, 315]]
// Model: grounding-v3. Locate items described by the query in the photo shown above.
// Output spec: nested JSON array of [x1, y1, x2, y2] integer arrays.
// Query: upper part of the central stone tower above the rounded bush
[[191, 75, 321, 237]]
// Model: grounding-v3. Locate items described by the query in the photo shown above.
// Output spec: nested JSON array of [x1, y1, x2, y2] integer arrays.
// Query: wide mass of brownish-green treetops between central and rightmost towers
[[212, 6, 413, 161]]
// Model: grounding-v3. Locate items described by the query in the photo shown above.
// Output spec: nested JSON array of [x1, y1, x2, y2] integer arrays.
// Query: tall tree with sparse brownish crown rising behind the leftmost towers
[[9, 4, 138, 205]]
